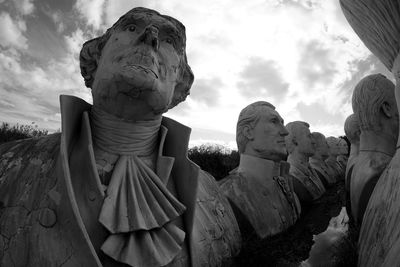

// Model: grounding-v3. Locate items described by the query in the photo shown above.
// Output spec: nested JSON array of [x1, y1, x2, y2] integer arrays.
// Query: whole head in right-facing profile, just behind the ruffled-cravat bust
[[236, 101, 288, 161]]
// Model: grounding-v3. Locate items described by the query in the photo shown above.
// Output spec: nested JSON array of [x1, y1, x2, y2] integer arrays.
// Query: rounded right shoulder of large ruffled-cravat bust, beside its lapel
[[194, 170, 241, 266]]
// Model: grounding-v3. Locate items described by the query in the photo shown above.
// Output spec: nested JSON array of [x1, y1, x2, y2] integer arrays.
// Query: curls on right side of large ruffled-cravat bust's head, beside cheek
[[168, 59, 194, 109]]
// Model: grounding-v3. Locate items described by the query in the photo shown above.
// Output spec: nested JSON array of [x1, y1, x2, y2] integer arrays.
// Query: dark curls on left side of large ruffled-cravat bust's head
[[79, 37, 103, 88]]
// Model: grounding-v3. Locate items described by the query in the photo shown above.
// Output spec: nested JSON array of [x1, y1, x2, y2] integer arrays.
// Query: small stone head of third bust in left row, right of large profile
[[285, 121, 315, 157]]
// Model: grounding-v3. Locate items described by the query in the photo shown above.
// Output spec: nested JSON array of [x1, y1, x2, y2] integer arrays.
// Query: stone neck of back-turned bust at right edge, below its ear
[[359, 131, 396, 156]]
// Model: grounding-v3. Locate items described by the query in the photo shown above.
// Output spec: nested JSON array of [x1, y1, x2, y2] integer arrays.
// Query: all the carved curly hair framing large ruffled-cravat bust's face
[[79, 7, 194, 108]]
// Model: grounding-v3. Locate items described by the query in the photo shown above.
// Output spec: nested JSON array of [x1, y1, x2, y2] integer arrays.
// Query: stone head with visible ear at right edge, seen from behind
[[352, 74, 399, 139]]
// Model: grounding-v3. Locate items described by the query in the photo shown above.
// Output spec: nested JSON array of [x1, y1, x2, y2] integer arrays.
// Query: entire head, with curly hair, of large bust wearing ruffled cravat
[[80, 7, 194, 120]]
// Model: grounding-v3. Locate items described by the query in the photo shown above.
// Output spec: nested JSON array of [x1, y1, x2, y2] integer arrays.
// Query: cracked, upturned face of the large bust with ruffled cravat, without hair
[[92, 11, 184, 120]]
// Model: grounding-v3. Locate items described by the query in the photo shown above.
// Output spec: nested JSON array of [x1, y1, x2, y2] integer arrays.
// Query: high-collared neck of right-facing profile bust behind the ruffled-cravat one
[[238, 154, 280, 182]]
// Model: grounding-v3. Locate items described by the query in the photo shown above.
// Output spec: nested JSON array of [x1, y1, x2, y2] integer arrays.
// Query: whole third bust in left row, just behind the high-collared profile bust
[[285, 121, 325, 202]]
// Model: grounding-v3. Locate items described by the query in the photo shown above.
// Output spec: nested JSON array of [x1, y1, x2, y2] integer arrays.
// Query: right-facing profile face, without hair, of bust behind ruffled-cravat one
[[244, 107, 289, 161]]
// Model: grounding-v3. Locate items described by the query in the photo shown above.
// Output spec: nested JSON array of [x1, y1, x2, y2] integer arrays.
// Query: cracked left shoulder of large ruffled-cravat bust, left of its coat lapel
[[0, 133, 98, 267]]
